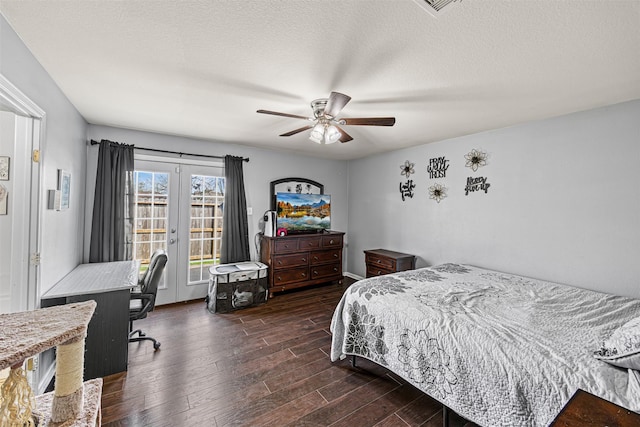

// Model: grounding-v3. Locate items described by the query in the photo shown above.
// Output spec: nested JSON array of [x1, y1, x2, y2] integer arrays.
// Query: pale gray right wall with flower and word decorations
[[348, 101, 640, 297]]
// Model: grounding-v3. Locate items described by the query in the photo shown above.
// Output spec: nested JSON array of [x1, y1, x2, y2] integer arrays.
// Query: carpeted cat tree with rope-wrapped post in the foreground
[[0, 301, 102, 427]]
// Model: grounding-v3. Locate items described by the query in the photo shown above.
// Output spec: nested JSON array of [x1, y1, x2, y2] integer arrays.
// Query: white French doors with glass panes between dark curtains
[[133, 157, 225, 305]]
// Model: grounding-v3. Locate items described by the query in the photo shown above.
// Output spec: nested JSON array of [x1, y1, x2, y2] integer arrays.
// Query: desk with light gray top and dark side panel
[[40, 261, 140, 380]]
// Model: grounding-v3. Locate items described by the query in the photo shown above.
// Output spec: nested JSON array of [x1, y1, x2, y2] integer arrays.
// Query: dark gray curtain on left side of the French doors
[[89, 139, 133, 262]]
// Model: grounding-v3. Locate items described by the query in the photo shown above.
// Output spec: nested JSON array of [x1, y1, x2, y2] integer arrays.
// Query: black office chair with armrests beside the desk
[[129, 249, 167, 350]]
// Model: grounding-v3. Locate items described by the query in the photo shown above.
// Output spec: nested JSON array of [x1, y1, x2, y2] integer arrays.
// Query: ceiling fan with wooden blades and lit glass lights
[[257, 92, 396, 144]]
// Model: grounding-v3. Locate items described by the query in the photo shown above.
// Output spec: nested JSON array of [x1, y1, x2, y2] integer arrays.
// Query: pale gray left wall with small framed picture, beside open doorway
[[0, 16, 87, 293]]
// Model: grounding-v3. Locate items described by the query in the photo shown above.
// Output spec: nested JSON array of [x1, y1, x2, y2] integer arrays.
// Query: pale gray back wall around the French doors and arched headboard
[[85, 125, 348, 264]]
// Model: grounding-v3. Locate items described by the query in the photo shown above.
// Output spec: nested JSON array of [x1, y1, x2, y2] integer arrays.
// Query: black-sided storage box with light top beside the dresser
[[206, 262, 269, 313]]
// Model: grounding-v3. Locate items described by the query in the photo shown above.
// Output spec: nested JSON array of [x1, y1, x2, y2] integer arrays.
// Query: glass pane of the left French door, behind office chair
[[133, 171, 169, 280]]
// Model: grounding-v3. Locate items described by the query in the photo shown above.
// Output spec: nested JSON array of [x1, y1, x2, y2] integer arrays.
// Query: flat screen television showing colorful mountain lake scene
[[276, 193, 331, 234]]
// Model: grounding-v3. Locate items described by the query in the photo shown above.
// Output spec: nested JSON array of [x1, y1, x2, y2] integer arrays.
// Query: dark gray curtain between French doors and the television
[[220, 156, 250, 264]]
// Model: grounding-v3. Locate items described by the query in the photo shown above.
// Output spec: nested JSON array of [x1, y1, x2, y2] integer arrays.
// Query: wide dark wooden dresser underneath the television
[[260, 231, 344, 296]]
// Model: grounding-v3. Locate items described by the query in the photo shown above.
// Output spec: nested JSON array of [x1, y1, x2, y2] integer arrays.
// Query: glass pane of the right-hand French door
[[188, 175, 224, 284]]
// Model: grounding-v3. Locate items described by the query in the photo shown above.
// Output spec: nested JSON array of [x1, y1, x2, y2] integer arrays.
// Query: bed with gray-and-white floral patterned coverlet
[[331, 264, 640, 427]]
